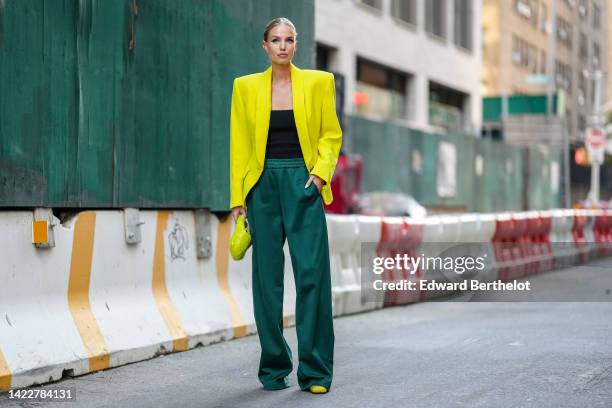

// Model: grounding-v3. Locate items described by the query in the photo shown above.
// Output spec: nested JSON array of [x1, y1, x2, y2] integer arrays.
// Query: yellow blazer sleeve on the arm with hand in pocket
[[311, 74, 342, 184]]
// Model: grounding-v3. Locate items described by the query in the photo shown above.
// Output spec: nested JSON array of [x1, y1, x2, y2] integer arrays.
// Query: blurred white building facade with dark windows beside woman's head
[[315, 0, 482, 135]]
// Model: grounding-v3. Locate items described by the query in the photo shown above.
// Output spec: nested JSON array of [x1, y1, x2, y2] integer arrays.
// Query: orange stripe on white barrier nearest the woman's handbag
[[216, 217, 247, 337]]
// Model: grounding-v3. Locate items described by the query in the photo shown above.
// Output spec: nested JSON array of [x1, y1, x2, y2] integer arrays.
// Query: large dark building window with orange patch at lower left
[[354, 57, 409, 119]]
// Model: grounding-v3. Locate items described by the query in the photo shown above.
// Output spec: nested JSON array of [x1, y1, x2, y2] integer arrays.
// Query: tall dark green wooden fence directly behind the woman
[[0, 0, 315, 210]]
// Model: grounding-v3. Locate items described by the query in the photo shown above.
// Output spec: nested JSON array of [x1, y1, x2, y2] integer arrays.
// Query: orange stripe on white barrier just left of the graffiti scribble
[[153, 211, 189, 351]]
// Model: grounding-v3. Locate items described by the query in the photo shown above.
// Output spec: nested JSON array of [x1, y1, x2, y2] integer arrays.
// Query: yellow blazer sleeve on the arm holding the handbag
[[230, 79, 251, 208]]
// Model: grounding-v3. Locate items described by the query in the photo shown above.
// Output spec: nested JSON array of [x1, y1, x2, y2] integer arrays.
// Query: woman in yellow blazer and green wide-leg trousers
[[230, 18, 342, 393]]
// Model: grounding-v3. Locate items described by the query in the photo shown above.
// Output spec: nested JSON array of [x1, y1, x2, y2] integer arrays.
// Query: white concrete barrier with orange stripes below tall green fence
[[0, 211, 255, 389]]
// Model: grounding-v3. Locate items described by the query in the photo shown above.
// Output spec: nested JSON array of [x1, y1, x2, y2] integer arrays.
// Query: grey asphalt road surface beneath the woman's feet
[[0, 260, 612, 408]]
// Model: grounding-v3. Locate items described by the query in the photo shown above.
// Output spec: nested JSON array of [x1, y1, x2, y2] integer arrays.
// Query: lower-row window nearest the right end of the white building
[[429, 82, 469, 131]]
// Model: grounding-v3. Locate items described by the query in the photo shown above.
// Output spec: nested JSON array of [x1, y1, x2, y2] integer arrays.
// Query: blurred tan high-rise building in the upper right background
[[482, 0, 611, 141]]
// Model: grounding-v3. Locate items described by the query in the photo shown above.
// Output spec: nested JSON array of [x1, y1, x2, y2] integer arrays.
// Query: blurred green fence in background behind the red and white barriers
[[345, 116, 562, 212]]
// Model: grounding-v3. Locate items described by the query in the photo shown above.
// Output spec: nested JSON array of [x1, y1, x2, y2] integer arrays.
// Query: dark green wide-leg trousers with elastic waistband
[[246, 158, 334, 390]]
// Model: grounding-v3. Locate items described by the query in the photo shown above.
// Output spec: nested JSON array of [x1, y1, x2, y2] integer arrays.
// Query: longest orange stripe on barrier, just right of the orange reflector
[[68, 211, 110, 372]]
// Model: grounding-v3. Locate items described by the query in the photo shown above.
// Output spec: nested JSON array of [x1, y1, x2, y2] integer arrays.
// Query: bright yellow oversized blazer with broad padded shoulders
[[230, 64, 342, 208]]
